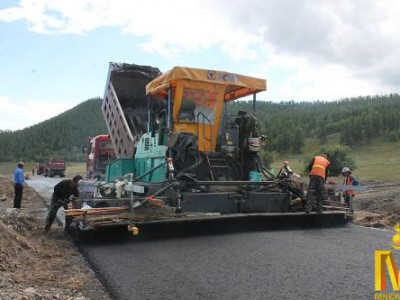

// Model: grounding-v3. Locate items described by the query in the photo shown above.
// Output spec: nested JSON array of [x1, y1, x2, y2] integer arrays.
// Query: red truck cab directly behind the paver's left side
[[86, 134, 115, 180]]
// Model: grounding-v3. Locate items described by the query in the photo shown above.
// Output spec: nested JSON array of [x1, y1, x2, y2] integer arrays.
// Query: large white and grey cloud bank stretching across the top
[[0, 0, 400, 100]]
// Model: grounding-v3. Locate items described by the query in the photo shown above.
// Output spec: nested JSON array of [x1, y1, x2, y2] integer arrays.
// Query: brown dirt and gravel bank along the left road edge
[[0, 177, 110, 300]]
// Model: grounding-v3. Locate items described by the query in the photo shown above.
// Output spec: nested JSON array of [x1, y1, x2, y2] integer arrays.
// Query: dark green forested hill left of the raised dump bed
[[0, 98, 107, 161]]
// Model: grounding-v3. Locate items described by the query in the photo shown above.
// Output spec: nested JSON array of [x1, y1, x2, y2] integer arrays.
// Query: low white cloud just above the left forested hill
[[0, 96, 74, 130]]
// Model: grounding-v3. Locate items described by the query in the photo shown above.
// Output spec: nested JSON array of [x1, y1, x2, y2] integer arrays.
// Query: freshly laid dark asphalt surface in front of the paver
[[27, 177, 400, 299]]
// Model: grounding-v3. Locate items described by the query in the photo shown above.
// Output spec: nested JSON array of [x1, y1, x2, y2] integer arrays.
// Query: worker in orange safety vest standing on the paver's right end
[[306, 153, 330, 213]]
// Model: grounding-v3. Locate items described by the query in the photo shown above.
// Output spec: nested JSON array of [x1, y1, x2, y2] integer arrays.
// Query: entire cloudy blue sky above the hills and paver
[[0, 0, 400, 130]]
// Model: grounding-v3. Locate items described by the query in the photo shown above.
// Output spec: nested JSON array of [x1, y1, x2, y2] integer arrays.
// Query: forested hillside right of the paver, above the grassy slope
[[232, 94, 400, 154]]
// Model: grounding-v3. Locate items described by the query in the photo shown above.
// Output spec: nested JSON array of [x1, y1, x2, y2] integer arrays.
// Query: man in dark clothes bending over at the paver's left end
[[45, 175, 82, 233]]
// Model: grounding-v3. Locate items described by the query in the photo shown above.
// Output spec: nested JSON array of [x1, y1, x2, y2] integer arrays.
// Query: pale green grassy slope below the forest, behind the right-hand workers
[[272, 135, 400, 181]]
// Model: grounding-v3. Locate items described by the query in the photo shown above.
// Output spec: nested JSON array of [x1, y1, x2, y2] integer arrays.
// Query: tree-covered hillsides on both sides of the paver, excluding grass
[[0, 94, 400, 161]]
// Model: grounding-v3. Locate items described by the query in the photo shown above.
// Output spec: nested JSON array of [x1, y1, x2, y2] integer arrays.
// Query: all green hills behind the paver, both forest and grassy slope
[[0, 94, 400, 180]]
